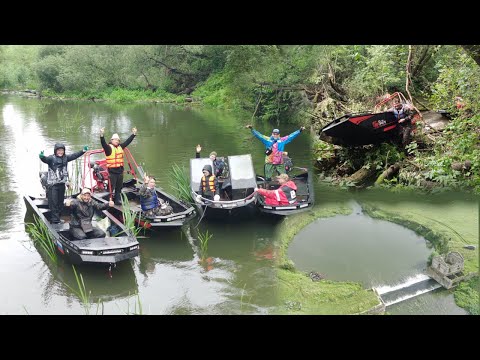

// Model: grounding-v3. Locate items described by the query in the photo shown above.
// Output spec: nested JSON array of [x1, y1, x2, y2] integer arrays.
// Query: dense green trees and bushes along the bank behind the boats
[[0, 45, 480, 192]]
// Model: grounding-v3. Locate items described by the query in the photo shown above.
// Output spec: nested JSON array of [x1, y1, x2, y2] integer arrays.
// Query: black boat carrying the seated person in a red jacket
[[257, 167, 315, 216]]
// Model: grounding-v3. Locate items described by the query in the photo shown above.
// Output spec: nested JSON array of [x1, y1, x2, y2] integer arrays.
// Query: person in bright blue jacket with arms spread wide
[[245, 125, 305, 181]]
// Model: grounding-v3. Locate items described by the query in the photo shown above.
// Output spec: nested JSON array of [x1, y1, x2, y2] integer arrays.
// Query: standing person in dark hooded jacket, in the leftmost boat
[[38, 143, 88, 224]]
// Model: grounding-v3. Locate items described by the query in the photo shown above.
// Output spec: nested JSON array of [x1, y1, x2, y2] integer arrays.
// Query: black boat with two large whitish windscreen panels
[[190, 154, 257, 219]]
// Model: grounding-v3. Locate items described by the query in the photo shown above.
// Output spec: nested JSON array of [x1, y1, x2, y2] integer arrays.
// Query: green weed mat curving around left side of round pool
[[277, 202, 379, 314]]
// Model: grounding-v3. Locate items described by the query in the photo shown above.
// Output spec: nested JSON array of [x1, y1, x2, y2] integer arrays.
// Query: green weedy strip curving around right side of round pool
[[358, 192, 479, 314]]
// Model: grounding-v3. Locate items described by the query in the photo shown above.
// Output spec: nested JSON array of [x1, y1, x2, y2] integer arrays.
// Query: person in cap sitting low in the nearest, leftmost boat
[[65, 187, 114, 240]]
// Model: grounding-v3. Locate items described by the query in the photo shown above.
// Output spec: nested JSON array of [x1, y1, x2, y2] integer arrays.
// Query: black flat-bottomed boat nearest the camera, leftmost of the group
[[23, 195, 139, 265]]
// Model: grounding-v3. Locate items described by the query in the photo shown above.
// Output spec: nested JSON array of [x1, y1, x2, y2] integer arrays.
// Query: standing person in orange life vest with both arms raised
[[100, 127, 137, 205]]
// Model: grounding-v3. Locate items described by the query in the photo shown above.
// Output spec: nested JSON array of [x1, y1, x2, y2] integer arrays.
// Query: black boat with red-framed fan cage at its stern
[[82, 148, 196, 230]]
